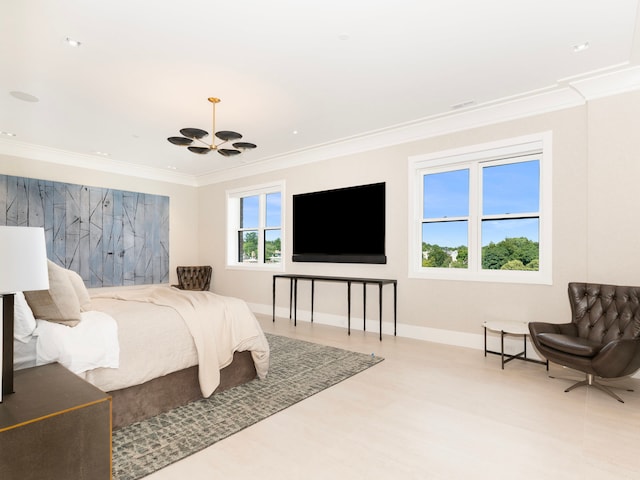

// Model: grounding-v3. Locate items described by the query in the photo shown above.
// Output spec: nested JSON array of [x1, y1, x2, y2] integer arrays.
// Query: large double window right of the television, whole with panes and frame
[[409, 134, 551, 283]]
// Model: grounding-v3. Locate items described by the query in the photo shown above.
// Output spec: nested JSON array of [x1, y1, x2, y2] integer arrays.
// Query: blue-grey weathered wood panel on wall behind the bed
[[0, 175, 169, 287]]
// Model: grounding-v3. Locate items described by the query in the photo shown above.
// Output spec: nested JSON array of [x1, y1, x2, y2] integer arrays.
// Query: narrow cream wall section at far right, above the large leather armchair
[[586, 92, 640, 285]]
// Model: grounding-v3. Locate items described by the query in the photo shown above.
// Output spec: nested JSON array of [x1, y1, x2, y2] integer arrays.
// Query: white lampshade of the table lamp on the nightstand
[[0, 226, 49, 294]]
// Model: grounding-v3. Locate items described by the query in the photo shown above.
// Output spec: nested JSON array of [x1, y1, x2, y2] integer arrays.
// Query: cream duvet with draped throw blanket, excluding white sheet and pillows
[[85, 287, 269, 397]]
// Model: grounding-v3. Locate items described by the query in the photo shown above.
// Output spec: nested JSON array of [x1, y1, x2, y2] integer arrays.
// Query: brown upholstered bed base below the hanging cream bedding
[[109, 352, 256, 430]]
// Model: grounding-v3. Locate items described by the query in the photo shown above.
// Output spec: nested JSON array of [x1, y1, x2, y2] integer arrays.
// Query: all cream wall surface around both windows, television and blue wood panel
[[5, 92, 640, 348]]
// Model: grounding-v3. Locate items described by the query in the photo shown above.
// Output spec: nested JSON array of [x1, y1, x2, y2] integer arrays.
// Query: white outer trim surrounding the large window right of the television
[[408, 131, 553, 285]]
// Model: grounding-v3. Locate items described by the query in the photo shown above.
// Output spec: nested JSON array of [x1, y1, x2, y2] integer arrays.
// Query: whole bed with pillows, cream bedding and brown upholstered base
[[14, 262, 269, 429]]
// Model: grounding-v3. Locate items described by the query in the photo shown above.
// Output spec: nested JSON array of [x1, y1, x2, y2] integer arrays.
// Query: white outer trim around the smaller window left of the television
[[225, 180, 287, 272]]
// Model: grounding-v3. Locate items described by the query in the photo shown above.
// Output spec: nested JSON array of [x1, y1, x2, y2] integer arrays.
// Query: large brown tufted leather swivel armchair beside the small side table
[[529, 283, 640, 403]]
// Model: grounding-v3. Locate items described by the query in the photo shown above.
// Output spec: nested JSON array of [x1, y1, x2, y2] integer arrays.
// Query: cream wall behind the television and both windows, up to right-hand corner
[[199, 100, 604, 346]]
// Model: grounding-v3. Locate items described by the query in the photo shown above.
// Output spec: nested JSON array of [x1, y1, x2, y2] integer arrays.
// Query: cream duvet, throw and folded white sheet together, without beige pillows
[[14, 286, 269, 396]]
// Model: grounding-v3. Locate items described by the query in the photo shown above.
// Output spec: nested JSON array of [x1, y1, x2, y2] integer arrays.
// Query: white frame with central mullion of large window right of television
[[408, 132, 553, 285]]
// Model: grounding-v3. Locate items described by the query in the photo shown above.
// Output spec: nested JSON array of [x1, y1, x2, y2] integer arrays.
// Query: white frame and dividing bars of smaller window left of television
[[226, 181, 286, 272]]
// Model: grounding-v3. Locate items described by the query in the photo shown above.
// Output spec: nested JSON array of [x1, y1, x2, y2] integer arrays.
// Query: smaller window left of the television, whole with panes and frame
[[227, 183, 284, 269]]
